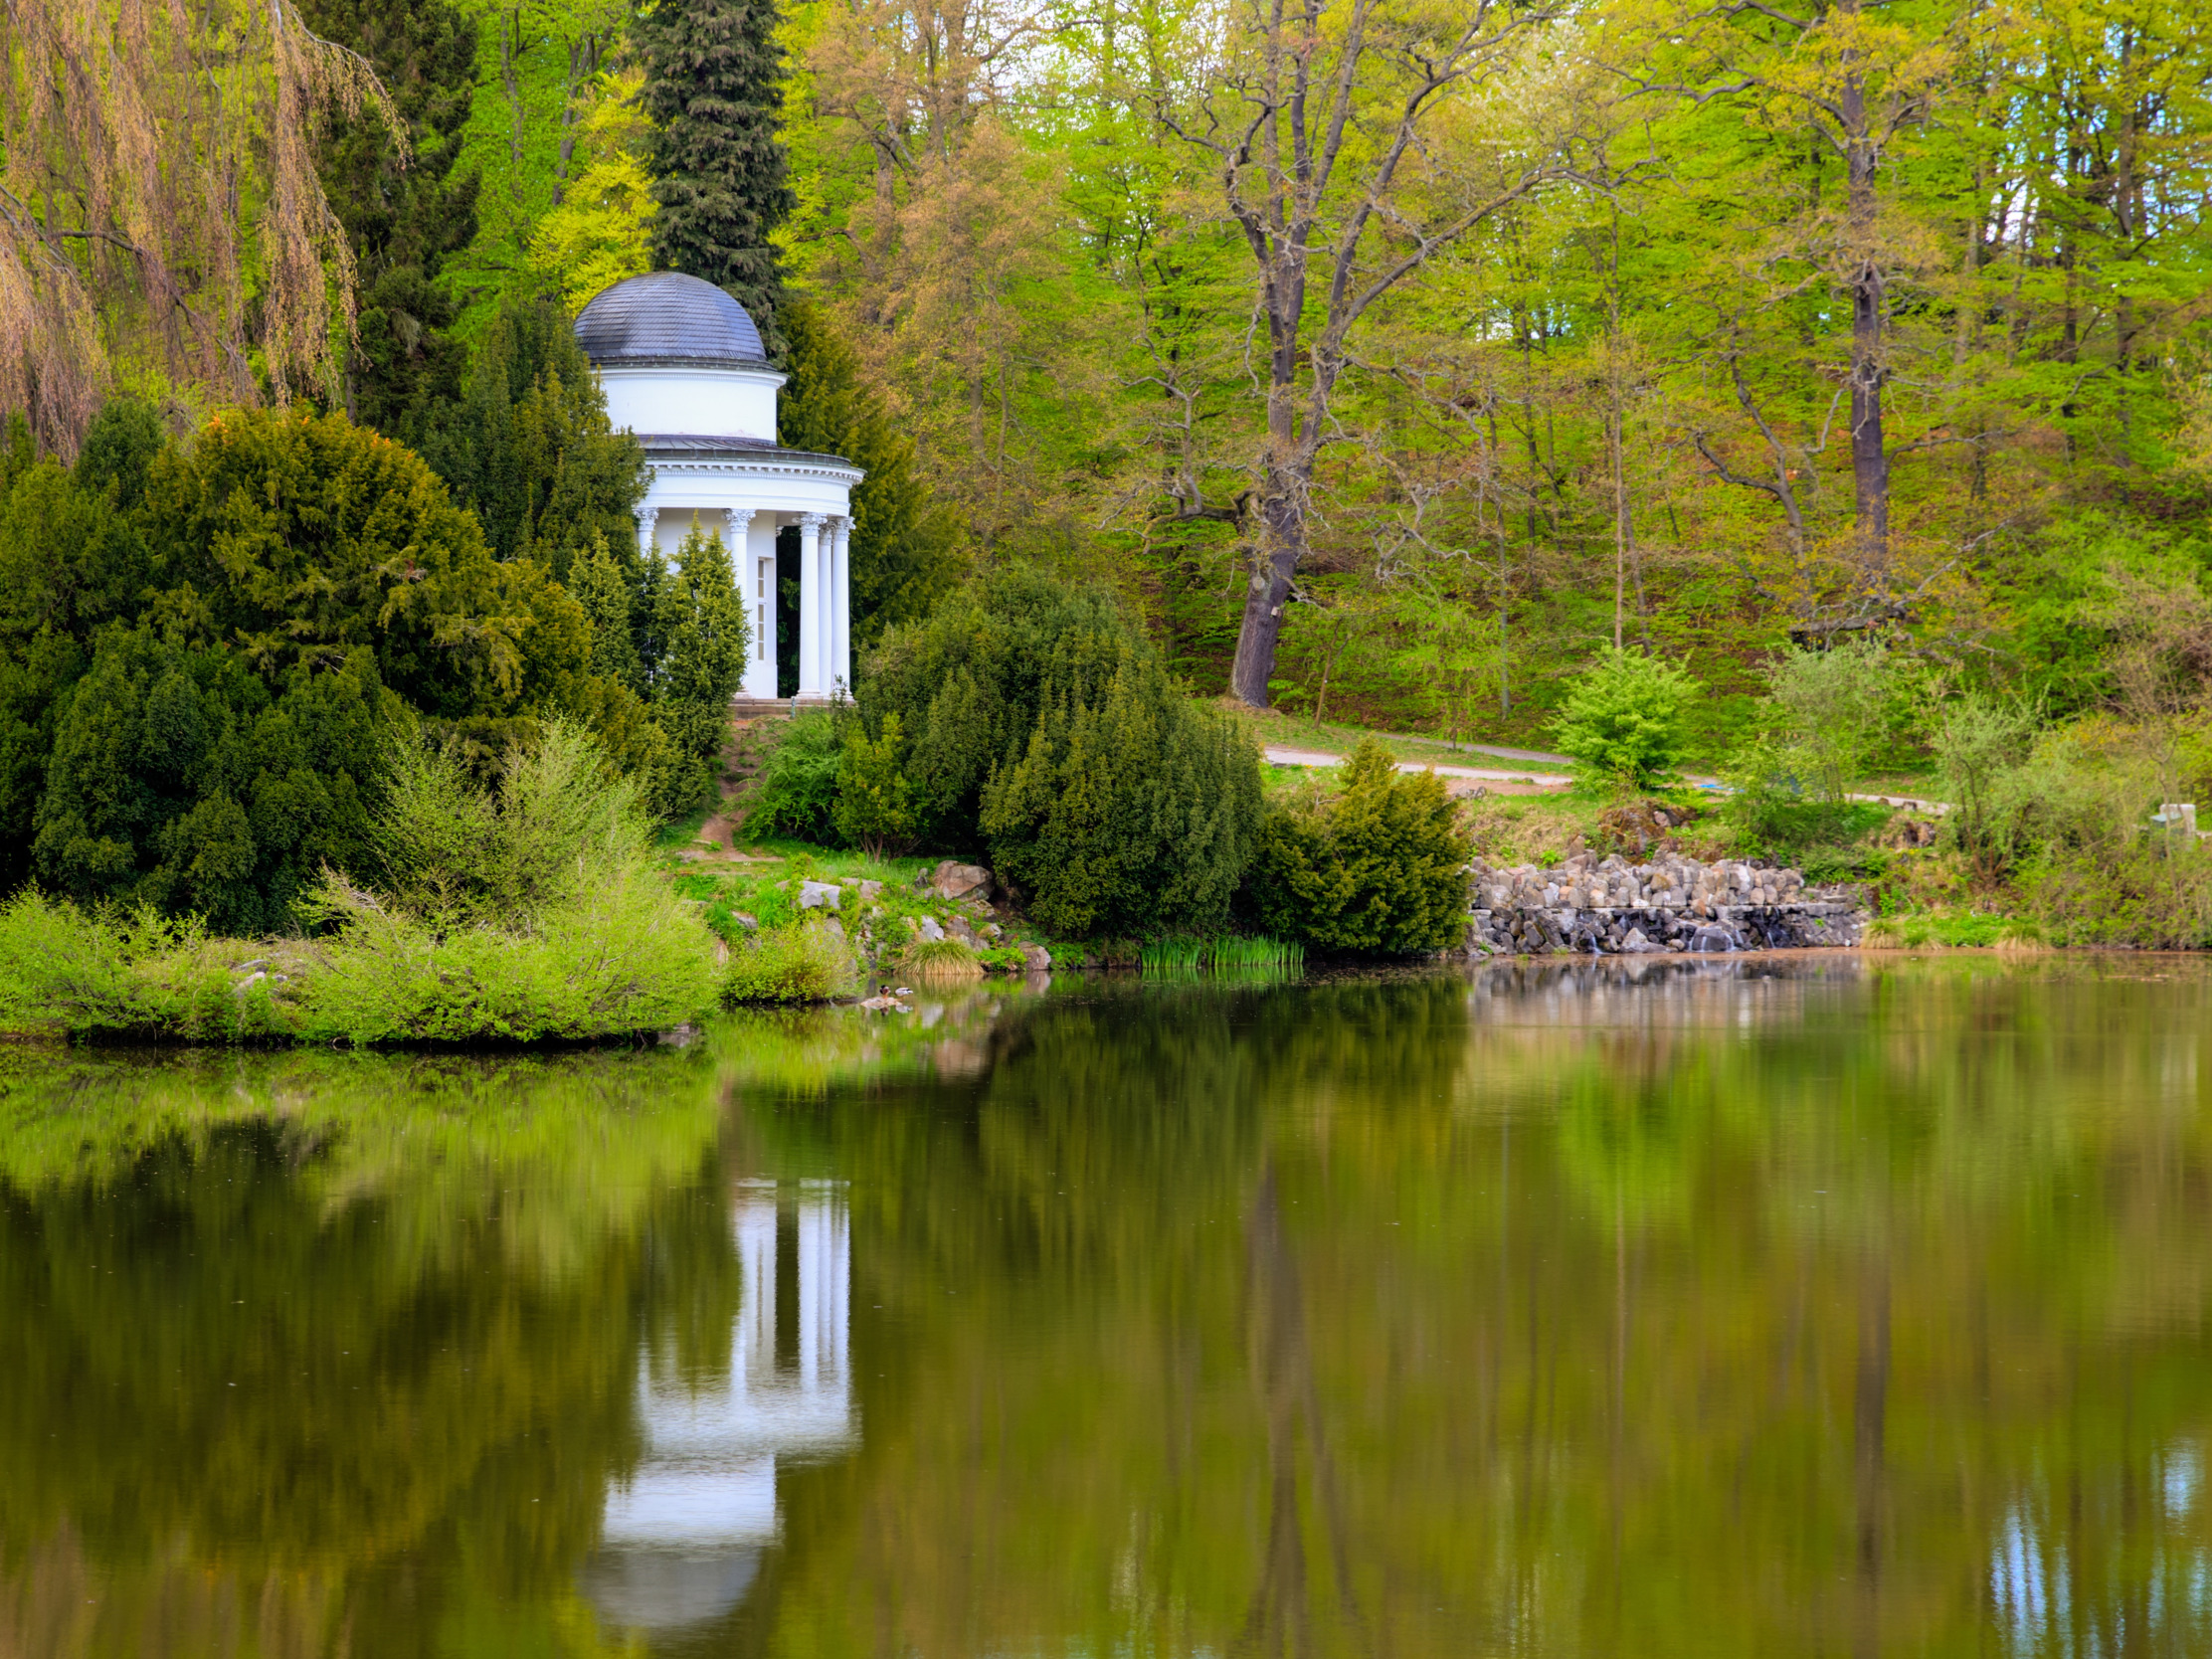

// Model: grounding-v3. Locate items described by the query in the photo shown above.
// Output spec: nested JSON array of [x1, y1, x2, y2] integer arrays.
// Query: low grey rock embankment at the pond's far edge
[[1467, 851, 1865, 956]]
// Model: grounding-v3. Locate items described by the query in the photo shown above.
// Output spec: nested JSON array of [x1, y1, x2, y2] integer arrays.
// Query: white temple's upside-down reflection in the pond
[[584, 1182, 856, 1630]]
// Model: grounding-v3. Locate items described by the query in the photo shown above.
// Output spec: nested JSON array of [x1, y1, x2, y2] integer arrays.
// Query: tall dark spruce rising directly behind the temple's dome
[[633, 0, 799, 338]]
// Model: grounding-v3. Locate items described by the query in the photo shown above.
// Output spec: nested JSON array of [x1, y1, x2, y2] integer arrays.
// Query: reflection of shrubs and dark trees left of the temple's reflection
[[0, 1057, 737, 1659]]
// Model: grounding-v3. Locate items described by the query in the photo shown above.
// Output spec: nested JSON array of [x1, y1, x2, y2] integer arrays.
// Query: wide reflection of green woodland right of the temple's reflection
[[759, 965, 2212, 1655]]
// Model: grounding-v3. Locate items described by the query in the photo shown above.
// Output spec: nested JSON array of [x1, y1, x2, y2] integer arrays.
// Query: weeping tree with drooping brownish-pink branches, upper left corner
[[0, 0, 407, 456]]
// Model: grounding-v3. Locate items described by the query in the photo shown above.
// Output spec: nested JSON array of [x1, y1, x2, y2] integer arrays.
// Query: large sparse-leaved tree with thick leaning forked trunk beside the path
[[1159, 0, 1564, 708]]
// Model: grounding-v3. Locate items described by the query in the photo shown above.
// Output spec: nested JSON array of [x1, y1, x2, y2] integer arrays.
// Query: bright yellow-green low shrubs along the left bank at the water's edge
[[0, 723, 714, 1044]]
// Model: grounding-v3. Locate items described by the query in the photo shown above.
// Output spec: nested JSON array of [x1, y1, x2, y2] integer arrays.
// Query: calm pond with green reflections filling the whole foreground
[[0, 956, 2212, 1659]]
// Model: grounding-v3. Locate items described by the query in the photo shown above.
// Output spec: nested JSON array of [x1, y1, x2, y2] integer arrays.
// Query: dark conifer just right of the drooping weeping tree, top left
[[300, 0, 480, 438]]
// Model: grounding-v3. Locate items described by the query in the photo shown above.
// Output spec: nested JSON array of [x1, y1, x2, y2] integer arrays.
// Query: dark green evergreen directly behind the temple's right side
[[777, 294, 962, 650]]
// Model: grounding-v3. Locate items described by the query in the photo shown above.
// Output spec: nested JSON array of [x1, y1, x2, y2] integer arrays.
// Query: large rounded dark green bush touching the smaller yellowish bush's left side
[[982, 638, 1261, 938]]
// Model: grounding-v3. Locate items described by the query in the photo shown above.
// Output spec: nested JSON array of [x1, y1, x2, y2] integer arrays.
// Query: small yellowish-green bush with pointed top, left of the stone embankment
[[1245, 739, 1469, 954]]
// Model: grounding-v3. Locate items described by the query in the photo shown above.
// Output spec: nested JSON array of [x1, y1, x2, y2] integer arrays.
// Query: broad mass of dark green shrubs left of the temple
[[0, 403, 698, 934]]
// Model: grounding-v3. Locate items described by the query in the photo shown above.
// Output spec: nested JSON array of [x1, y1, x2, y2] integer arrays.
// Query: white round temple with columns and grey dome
[[575, 270, 862, 701]]
